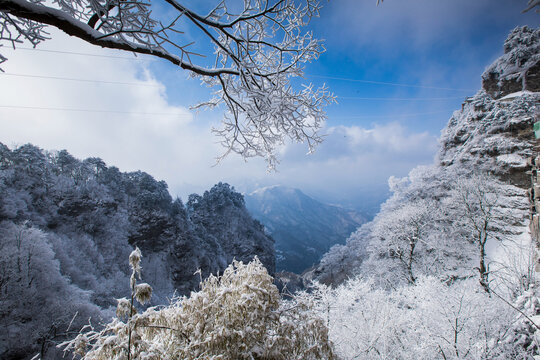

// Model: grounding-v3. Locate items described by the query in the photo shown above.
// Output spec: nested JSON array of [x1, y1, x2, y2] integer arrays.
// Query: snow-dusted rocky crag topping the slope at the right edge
[[439, 27, 540, 188]]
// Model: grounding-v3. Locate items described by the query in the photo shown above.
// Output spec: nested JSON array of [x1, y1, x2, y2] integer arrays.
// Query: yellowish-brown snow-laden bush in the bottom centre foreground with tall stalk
[[64, 250, 336, 360]]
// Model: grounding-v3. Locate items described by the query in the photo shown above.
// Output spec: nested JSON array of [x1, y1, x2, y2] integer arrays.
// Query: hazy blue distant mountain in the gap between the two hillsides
[[245, 186, 366, 273]]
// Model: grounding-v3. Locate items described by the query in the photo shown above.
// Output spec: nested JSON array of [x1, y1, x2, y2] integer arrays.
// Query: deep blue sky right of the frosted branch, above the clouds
[[306, 0, 539, 133]]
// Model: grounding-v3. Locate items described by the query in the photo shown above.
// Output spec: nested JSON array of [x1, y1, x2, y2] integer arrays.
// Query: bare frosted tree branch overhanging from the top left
[[0, 0, 334, 168]]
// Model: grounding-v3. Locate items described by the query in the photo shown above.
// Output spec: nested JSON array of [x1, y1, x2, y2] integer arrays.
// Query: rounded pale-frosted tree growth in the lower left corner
[[0, 221, 100, 359]]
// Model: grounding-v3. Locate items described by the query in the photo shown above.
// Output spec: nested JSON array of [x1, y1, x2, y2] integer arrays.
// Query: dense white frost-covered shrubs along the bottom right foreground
[[312, 277, 514, 360]]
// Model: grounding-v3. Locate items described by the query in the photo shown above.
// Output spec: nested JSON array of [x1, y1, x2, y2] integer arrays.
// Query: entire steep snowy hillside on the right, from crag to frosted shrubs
[[304, 27, 540, 359]]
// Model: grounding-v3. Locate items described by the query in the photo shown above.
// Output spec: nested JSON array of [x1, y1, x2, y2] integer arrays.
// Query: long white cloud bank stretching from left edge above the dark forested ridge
[[0, 28, 436, 211]]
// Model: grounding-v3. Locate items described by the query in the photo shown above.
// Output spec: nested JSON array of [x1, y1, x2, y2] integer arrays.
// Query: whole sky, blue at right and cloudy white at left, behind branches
[[0, 0, 540, 214]]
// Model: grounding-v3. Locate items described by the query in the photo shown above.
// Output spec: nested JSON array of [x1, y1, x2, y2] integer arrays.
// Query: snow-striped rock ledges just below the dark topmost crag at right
[[439, 90, 540, 188]]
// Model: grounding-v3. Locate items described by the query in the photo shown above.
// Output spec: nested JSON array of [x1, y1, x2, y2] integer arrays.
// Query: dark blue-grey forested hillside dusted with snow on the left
[[0, 144, 275, 359]]
